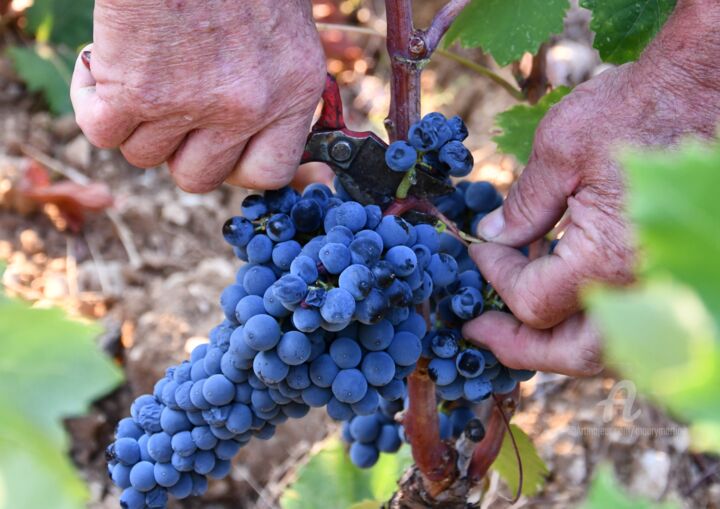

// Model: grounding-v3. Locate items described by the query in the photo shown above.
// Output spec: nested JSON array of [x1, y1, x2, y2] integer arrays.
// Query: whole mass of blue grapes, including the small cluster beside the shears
[[107, 113, 532, 509]]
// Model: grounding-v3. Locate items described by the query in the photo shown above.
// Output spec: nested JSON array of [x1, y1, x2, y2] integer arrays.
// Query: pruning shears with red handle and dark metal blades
[[301, 75, 454, 208]]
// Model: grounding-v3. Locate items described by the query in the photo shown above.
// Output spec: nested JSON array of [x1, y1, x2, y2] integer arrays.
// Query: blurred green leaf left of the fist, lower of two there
[[7, 44, 74, 115]]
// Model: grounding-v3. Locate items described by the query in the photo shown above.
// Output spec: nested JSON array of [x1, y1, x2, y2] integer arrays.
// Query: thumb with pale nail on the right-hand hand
[[477, 152, 574, 246]]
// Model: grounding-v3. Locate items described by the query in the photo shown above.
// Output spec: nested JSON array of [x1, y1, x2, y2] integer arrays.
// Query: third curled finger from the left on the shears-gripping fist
[[168, 129, 247, 193]]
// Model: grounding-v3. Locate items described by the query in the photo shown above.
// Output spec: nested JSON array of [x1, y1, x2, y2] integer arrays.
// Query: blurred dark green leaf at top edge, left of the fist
[[25, 0, 95, 50]]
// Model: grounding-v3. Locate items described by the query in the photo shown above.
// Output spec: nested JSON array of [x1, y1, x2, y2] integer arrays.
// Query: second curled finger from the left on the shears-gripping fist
[[120, 119, 192, 168]]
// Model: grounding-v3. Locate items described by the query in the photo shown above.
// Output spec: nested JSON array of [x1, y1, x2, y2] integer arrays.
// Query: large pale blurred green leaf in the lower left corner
[[0, 293, 121, 509]]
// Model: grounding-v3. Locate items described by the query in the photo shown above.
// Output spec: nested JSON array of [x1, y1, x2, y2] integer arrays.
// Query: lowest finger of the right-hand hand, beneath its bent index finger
[[463, 311, 602, 376]]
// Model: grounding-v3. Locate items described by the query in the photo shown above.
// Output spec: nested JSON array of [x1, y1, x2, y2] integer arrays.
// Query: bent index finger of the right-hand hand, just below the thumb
[[470, 190, 634, 329]]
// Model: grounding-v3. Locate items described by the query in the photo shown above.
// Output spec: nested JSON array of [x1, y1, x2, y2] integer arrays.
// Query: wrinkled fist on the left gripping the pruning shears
[[71, 0, 325, 192]]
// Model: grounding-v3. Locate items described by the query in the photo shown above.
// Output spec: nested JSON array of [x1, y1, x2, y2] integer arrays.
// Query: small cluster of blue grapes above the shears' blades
[[385, 112, 474, 177]]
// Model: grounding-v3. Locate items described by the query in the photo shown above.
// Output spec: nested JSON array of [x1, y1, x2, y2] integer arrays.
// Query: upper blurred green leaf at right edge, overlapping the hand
[[622, 144, 720, 328]]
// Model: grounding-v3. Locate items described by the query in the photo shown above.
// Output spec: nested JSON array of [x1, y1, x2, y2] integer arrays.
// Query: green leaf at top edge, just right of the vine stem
[[445, 0, 570, 66]]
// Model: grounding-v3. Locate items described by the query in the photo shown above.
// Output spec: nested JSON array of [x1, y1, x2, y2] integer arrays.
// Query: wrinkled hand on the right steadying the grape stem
[[464, 0, 720, 375]]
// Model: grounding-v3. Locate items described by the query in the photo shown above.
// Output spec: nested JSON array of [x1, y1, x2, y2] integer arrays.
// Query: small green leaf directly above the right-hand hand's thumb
[[493, 87, 570, 164]]
